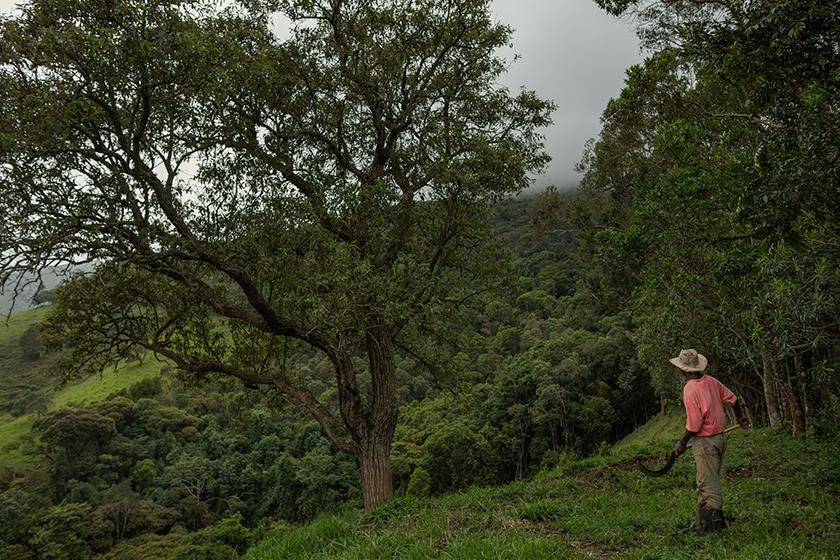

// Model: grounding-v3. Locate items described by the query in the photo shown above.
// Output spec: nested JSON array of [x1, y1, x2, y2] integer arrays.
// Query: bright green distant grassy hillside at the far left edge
[[0, 307, 164, 466]]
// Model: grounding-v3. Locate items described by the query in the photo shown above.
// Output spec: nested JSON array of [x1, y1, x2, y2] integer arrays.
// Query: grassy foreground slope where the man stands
[[246, 424, 840, 560]]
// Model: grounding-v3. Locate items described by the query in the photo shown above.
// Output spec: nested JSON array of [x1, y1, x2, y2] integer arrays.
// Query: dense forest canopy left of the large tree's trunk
[[0, 370, 359, 560]]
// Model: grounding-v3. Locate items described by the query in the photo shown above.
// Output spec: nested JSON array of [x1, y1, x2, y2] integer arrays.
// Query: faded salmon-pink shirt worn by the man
[[683, 375, 737, 437]]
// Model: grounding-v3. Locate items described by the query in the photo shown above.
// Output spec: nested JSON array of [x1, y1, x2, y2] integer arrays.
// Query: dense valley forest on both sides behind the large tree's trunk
[[0, 199, 659, 559]]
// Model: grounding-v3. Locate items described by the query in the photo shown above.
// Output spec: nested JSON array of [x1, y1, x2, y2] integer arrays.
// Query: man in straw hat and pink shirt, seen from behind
[[670, 349, 749, 535]]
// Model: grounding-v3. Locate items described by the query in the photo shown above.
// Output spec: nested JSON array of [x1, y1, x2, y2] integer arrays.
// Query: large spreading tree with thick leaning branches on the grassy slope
[[0, 0, 552, 508]]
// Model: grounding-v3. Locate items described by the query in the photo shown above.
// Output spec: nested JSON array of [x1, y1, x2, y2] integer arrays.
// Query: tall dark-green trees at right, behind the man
[[579, 0, 840, 433]]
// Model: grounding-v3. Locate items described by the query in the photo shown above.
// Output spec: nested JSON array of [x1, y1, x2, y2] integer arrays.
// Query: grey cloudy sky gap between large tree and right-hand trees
[[0, 0, 642, 189]]
